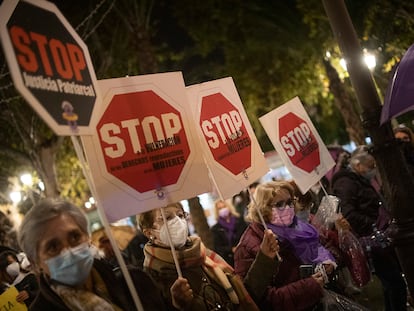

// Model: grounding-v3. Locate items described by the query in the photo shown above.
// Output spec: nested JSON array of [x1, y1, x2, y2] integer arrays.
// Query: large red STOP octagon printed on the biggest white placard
[[97, 90, 190, 193]]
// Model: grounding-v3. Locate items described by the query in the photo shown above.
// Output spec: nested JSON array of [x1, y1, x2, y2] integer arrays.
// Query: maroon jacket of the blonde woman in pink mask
[[234, 223, 323, 311]]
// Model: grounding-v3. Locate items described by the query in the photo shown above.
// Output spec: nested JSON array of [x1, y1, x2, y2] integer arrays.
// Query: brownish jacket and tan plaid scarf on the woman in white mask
[[144, 237, 261, 311]]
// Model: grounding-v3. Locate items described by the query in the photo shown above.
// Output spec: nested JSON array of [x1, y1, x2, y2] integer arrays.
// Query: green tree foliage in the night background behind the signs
[[0, 0, 414, 204]]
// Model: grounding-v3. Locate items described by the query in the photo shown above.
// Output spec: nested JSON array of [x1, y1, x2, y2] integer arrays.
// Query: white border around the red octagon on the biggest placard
[[82, 72, 211, 221]]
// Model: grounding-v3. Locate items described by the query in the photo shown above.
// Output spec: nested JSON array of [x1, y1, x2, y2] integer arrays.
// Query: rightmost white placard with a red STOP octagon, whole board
[[259, 97, 335, 193]]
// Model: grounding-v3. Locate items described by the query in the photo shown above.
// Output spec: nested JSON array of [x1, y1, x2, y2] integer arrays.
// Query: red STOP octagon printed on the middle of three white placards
[[200, 93, 251, 175]]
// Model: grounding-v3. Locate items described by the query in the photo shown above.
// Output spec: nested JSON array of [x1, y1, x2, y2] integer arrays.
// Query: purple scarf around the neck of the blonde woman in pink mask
[[267, 216, 335, 264]]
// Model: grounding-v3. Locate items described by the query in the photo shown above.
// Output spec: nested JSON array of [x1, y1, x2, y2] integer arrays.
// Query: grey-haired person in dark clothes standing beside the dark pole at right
[[332, 145, 407, 311]]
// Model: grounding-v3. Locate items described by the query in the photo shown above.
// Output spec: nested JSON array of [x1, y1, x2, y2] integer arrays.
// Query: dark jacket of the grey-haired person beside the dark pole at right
[[331, 169, 383, 236]]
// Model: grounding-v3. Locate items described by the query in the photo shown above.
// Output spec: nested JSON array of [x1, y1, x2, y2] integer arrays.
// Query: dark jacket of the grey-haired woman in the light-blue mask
[[29, 260, 167, 311]]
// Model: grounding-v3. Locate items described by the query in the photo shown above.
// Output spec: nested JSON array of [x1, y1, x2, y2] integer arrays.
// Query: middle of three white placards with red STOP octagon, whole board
[[187, 78, 269, 198]]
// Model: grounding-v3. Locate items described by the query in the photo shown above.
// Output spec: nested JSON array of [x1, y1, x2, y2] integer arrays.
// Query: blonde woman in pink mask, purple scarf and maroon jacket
[[234, 181, 336, 310]]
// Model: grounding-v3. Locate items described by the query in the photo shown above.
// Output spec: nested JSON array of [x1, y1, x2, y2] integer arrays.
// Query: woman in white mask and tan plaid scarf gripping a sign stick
[[137, 204, 278, 311]]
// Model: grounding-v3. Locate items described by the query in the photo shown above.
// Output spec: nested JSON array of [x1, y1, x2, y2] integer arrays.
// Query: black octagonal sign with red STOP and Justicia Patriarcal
[[0, 0, 97, 135]]
